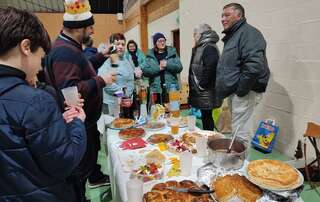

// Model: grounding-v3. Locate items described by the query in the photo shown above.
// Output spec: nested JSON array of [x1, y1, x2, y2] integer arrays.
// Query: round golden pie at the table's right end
[[247, 159, 300, 189]]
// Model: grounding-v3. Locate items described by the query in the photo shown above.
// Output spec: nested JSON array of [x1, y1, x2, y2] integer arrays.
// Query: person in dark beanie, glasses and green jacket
[[141, 33, 182, 93]]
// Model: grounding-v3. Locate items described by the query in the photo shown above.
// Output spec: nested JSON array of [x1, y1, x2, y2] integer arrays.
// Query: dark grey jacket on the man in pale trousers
[[216, 18, 270, 99]]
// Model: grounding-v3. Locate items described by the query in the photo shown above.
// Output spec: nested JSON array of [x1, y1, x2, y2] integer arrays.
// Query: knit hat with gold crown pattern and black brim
[[63, 0, 94, 29]]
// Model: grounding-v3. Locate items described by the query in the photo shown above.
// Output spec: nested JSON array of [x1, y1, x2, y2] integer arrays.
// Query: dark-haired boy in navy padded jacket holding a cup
[[0, 8, 86, 202]]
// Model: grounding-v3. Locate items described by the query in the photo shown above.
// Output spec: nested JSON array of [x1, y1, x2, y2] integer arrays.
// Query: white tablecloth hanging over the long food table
[[98, 115, 204, 202]]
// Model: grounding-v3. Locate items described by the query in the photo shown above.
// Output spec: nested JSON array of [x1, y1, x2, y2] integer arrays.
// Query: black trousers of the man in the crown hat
[[68, 124, 102, 202]]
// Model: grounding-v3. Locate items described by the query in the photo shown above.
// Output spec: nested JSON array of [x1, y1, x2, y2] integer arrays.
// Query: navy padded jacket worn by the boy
[[0, 65, 86, 202]]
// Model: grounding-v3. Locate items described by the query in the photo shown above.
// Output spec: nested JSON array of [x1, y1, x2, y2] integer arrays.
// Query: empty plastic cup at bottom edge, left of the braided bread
[[126, 179, 143, 202]]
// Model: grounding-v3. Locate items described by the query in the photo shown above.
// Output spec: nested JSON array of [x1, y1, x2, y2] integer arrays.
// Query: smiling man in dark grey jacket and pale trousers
[[216, 3, 270, 141]]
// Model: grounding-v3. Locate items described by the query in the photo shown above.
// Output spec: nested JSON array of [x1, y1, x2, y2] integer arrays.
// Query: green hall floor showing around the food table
[[86, 113, 320, 202]]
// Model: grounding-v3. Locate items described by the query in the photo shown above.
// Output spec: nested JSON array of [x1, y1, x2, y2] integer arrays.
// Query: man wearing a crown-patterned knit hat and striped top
[[46, 0, 115, 202]]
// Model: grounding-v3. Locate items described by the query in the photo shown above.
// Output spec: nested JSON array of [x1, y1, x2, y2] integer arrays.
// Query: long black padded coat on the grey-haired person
[[189, 31, 219, 110]]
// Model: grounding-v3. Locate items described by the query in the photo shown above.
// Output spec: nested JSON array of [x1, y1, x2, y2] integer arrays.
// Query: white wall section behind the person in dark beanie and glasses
[[148, 10, 179, 48]]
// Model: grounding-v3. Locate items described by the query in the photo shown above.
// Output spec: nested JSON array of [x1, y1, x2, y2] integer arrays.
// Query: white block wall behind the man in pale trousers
[[179, 0, 320, 156]]
